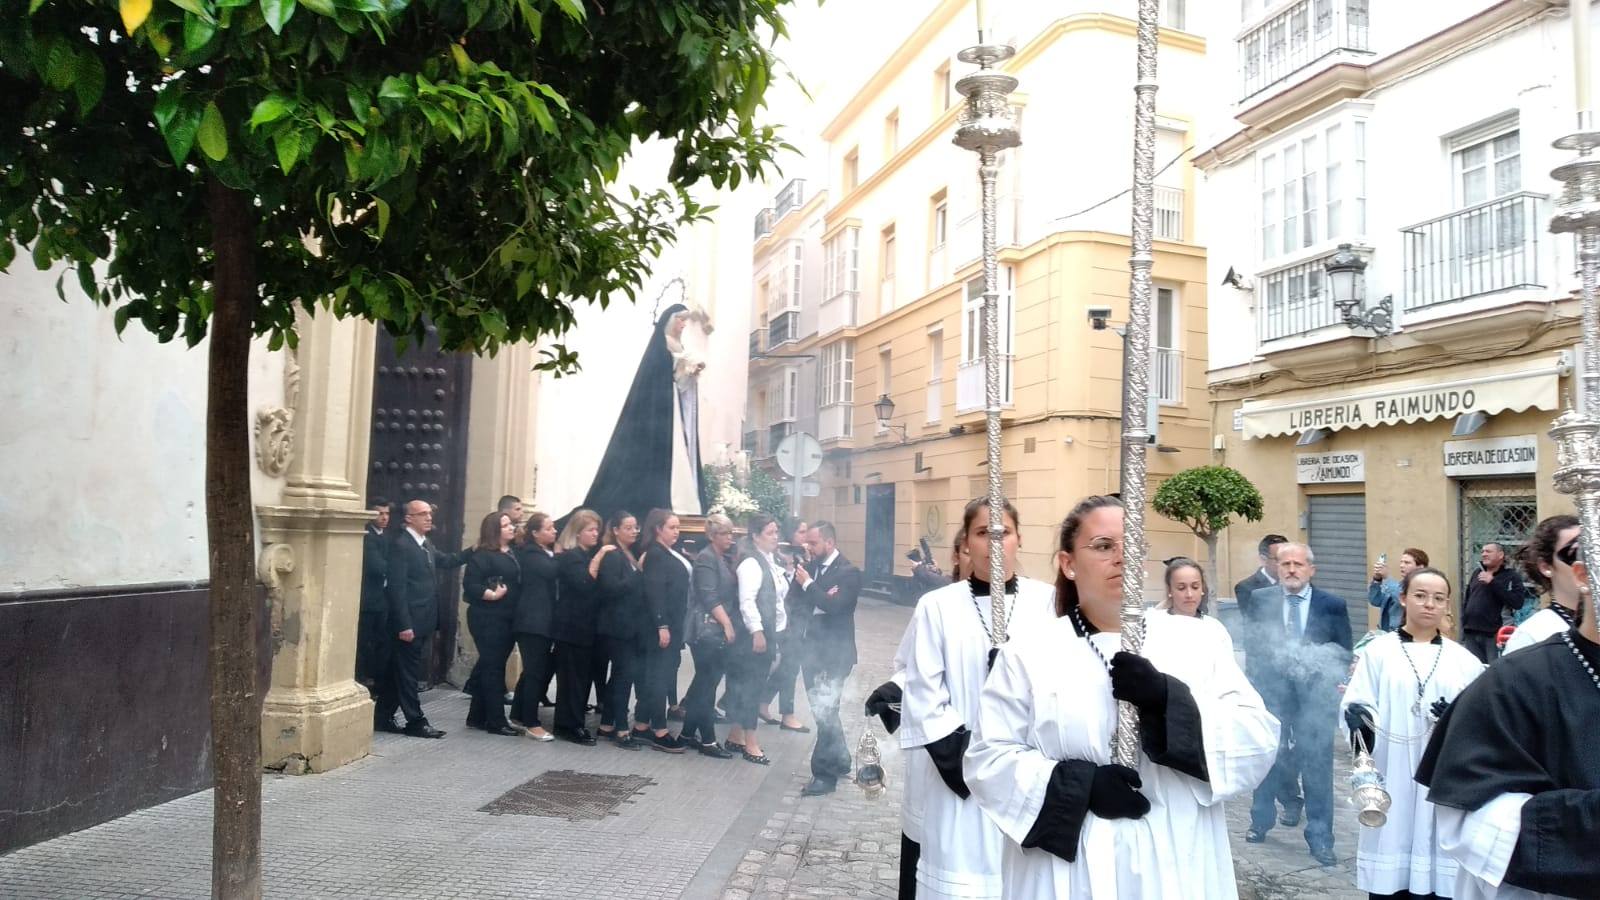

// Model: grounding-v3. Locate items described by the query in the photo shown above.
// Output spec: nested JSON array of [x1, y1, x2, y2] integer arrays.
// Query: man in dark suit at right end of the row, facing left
[[790, 522, 861, 798]]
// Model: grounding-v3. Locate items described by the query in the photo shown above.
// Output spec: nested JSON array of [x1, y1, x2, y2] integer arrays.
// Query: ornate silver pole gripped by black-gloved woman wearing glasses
[[1112, 0, 1160, 767]]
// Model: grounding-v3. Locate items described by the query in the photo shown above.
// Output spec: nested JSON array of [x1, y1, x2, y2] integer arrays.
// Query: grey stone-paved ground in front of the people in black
[[0, 592, 1360, 900]]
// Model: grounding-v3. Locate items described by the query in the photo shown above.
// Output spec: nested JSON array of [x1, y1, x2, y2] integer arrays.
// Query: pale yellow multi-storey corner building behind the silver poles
[[746, 0, 1210, 591]]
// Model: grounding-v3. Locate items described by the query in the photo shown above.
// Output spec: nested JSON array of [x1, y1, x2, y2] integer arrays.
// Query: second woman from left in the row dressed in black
[[510, 512, 557, 741]]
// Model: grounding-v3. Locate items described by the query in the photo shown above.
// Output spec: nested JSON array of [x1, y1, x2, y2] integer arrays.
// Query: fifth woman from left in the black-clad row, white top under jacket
[[634, 509, 693, 753]]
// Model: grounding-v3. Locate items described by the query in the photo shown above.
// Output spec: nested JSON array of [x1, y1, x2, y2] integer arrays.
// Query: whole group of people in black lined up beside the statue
[[357, 496, 861, 794]]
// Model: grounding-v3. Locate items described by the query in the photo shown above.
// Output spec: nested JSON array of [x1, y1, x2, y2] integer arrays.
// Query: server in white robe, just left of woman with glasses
[[896, 500, 1054, 900]]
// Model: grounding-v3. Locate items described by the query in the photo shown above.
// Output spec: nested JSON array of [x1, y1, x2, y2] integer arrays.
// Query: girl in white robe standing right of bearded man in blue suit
[[1342, 569, 1483, 900]]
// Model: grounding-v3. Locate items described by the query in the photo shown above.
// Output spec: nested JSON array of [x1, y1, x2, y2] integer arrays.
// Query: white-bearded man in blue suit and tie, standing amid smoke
[[1245, 543, 1354, 866]]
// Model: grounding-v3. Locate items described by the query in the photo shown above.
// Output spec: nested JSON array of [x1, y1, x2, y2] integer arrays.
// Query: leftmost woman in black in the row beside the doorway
[[461, 512, 522, 737]]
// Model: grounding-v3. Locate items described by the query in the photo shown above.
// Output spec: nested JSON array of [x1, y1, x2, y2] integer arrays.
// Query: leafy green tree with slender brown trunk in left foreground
[[0, 0, 787, 897]]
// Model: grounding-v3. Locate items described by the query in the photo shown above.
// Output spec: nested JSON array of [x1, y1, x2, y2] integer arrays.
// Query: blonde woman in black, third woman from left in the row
[[550, 509, 600, 746]]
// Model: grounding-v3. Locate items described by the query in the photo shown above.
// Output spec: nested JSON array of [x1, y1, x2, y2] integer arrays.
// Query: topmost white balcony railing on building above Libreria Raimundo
[[1238, 0, 1370, 98]]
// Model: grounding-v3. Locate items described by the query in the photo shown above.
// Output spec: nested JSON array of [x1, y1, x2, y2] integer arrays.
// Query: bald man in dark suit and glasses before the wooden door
[[376, 500, 461, 738]]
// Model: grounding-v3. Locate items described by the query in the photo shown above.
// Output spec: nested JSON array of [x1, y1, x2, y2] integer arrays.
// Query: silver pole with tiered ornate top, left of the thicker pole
[[955, 24, 1022, 647]]
